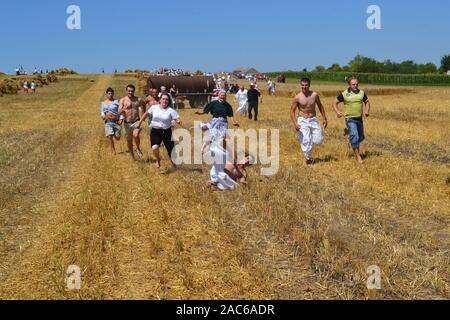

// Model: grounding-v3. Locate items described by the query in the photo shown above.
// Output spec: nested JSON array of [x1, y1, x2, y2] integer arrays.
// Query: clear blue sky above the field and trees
[[0, 0, 450, 73]]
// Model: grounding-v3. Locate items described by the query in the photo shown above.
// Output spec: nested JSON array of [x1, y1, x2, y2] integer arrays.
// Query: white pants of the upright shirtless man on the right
[[298, 117, 323, 160]]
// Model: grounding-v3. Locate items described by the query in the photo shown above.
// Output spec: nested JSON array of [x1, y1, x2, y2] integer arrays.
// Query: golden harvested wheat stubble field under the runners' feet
[[0, 75, 450, 299]]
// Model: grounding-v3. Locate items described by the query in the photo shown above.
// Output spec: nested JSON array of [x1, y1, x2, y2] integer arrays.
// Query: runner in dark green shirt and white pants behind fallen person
[[195, 91, 239, 142]]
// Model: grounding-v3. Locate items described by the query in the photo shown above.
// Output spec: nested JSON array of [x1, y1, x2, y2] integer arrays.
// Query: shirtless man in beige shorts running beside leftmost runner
[[119, 84, 145, 161]]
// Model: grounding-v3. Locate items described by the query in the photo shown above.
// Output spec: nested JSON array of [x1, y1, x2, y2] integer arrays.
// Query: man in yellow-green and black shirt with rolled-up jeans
[[333, 77, 370, 164]]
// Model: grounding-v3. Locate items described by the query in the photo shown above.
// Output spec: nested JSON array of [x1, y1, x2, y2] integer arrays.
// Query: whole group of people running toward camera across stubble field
[[101, 78, 370, 190]]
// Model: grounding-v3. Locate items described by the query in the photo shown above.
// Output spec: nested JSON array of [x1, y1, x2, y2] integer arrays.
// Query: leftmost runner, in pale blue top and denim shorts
[[101, 88, 124, 155]]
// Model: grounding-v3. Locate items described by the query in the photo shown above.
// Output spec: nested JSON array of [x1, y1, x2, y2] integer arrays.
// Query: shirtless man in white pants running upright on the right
[[291, 78, 328, 165]]
